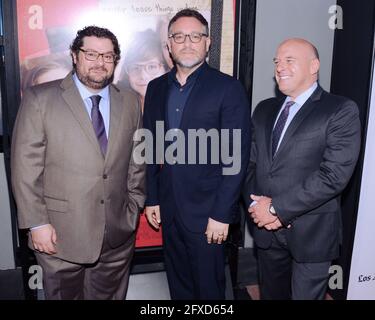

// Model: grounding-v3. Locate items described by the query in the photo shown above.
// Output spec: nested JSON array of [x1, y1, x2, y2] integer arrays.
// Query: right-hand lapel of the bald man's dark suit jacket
[[274, 86, 323, 160]]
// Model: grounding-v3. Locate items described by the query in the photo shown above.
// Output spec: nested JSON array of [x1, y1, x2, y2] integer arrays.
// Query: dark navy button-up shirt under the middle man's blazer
[[167, 63, 206, 129]]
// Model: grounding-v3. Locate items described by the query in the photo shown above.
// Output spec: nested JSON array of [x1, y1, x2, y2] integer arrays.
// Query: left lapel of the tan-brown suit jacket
[[61, 73, 102, 155]]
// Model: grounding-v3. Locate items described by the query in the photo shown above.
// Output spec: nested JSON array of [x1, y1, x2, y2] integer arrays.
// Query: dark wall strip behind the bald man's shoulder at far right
[[331, 0, 375, 299]]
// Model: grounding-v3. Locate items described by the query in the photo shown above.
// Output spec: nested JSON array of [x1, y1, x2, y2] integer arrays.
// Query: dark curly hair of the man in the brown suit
[[70, 26, 121, 68]]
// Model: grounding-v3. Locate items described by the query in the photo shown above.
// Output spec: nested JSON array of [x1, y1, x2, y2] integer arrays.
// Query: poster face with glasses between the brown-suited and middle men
[[127, 58, 165, 97]]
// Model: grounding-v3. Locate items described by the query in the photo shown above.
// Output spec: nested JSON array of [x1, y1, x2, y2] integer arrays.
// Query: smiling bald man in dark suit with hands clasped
[[244, 39, 360, 299]]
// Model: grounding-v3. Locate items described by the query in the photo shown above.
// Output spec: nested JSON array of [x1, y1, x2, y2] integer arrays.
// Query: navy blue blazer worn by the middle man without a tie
[[144, 64, 251, 232]]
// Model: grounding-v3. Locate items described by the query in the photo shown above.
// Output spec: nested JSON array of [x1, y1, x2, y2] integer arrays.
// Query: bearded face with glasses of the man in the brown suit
[[72, 36, 116, 91]]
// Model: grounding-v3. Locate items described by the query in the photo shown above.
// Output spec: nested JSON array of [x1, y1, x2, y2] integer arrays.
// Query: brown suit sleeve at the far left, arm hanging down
[[11, 89, 50, 229]]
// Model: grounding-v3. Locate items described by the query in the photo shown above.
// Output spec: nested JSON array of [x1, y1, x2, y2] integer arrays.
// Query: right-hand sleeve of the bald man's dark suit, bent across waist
[[272, 100, 361, 225]]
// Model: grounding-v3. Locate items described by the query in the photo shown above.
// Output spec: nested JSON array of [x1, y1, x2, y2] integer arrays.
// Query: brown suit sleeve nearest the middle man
[[128, 102, 145, 213]]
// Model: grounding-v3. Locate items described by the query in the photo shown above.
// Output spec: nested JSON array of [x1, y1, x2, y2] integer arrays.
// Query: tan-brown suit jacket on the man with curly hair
[[11, 74, 145, 263]]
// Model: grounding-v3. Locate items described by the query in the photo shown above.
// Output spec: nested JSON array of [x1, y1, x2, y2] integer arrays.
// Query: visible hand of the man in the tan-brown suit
[[30, 224, 57, 254]]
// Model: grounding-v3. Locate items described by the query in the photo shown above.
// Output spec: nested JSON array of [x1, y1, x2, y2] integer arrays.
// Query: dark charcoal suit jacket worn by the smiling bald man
[[244, 86, 361, 262]]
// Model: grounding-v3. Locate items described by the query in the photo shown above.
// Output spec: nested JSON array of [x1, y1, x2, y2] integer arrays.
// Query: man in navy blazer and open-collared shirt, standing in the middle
[[144, 9, 250, 299]]
